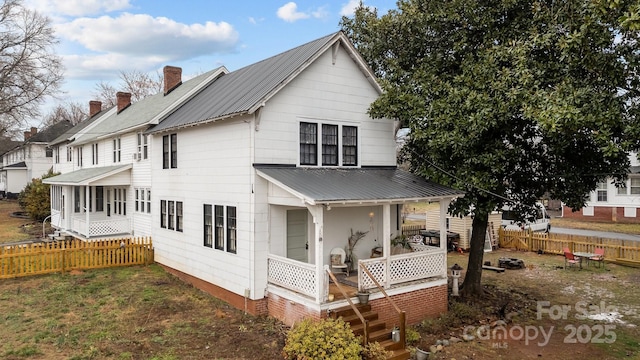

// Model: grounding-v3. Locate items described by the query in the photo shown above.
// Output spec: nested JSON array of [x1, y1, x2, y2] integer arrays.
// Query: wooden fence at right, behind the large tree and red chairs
[[498, 228, 640, 266]]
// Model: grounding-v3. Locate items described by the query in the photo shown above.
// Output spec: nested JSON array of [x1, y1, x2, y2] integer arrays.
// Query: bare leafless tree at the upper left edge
[[0, 0, 63, 136]]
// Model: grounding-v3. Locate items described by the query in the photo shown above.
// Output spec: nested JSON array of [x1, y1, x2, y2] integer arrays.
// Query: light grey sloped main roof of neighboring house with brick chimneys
[[75, 67, 226, 145]]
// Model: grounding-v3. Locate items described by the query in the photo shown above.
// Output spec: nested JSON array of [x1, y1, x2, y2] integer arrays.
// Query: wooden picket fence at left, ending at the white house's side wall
[[0, 237, 153, 279]]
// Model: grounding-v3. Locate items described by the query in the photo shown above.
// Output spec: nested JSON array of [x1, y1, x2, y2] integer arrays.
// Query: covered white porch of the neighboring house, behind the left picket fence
[[44, 164, 132, 240]]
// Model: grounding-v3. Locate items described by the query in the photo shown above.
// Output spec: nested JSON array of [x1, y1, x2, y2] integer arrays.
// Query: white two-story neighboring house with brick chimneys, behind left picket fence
[[45, 66, 226, 239]]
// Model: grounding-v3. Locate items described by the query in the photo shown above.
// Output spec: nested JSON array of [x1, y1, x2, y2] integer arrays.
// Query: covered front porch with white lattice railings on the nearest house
[[257, 167, 462, 311]]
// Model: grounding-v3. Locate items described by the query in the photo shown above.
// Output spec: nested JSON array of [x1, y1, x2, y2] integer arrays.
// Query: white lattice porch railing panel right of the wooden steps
[[358, 246, 447, 290]]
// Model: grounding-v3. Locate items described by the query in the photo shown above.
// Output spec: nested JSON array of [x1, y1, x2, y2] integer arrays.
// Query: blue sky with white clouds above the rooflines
[[24, 0, 396, 112]]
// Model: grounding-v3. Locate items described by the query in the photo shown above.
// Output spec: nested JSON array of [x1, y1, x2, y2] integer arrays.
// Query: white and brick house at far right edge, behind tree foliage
[[562, 153, 640, 223]]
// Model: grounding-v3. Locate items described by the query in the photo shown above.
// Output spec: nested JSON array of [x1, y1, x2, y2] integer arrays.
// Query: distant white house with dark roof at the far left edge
[[0, 121, 72, 197]]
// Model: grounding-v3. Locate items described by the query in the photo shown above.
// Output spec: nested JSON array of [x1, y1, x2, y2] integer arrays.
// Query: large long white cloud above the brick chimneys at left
[[55, 13, 239, 70]]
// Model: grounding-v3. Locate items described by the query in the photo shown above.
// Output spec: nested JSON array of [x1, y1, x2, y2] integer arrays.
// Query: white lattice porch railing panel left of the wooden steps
[[267, 254, 319, 300]]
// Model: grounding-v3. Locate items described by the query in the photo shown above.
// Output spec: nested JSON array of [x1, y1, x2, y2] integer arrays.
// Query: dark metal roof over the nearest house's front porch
[[254, 165, 464, 204]]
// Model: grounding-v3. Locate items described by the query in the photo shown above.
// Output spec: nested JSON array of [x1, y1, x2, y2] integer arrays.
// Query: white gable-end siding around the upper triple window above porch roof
[[255, 44, 396, 166]]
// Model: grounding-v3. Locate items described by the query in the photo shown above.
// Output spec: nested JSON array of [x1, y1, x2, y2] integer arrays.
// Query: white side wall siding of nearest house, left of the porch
[[151, 119, 262, 296]]
